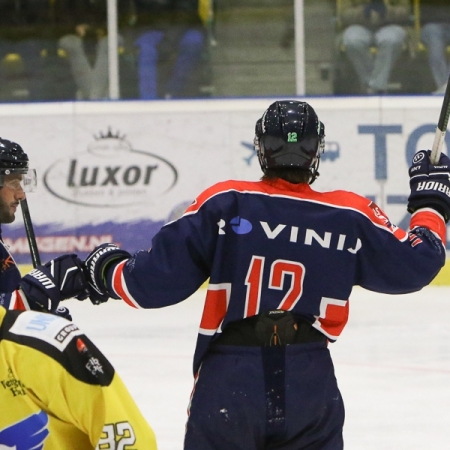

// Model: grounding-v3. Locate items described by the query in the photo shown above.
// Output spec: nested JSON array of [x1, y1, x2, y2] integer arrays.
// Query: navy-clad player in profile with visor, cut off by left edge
[[0, 138, 87, 318]]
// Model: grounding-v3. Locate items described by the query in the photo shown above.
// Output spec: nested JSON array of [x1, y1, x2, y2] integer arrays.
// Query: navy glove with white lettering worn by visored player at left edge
[[20, 254, 89, 317]]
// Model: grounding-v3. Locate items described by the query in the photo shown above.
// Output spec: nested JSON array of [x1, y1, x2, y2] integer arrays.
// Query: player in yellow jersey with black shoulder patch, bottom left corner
[[0, 307, 157, 450]]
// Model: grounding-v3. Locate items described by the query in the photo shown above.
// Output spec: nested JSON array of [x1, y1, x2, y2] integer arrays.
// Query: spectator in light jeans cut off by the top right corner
[[420, 0, 450, 94]]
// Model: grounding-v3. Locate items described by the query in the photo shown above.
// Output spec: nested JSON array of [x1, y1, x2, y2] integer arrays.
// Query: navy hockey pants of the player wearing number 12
[[184, 342, 345, 450]]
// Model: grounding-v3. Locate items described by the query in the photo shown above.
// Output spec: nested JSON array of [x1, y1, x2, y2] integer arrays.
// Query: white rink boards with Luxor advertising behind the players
[[0, 96, 450, 284]]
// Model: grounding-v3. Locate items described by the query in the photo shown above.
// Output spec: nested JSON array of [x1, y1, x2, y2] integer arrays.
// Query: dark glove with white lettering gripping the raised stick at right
[[407, 150, 450, 222]]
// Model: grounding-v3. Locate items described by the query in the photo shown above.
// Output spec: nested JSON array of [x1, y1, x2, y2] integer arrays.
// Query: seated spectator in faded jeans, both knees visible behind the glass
[[340, 0, 411, 94]]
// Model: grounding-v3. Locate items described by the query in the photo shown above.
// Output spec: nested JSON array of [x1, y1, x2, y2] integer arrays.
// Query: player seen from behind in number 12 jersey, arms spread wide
[[79, 101, 450, 450]]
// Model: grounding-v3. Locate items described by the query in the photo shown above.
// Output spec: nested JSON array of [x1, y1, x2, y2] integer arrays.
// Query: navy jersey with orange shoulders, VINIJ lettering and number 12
[[103, 180, 446, 371]]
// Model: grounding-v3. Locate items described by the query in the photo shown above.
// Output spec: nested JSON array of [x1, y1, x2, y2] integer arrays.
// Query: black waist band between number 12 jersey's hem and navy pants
[[213, 309, 327, 347]]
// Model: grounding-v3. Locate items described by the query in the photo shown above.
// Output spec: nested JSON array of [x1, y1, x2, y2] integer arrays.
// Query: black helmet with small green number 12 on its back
[[254, 100, 325, 183]]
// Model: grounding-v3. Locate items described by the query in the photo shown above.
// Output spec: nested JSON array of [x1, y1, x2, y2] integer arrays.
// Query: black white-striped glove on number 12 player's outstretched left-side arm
[[84, 244, 131, 304]]
